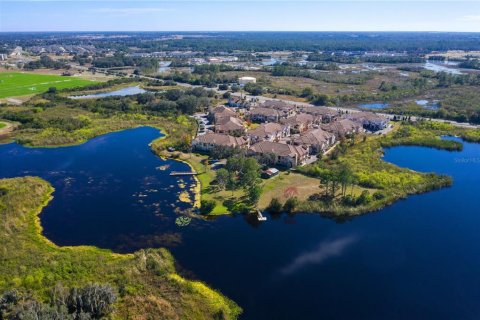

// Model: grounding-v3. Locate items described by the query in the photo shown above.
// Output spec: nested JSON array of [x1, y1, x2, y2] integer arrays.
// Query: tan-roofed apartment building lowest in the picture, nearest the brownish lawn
[[249, 141, 309, 168]]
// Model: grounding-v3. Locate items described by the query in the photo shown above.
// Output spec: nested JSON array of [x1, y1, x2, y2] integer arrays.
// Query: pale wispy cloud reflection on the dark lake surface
[[280, 236, 357, 276]]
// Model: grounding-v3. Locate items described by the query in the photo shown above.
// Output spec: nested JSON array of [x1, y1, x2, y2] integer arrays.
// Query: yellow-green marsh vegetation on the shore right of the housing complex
[[298, 124, 461, 216]]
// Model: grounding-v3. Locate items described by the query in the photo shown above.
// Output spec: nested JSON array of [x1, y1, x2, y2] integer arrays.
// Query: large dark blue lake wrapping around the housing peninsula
[[0, 128, 480, 319]]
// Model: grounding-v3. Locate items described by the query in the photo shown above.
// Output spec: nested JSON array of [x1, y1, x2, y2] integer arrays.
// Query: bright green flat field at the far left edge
[[0, 72, 95, 98]]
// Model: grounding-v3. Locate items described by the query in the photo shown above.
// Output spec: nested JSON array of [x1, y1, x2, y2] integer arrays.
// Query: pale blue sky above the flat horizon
[[0, 0, 480, 32]]
